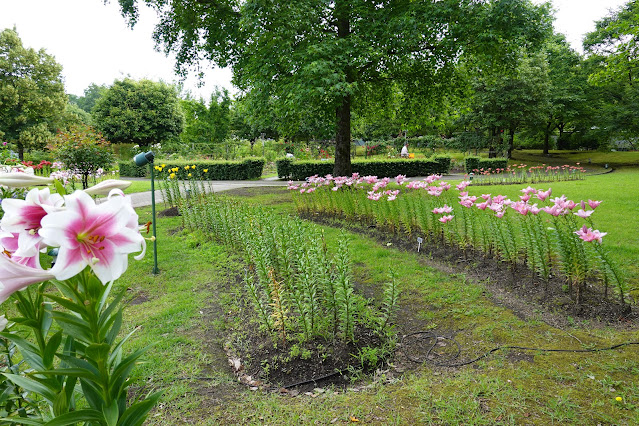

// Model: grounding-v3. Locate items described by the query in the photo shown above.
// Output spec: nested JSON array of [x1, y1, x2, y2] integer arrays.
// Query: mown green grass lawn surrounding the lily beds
[[117, 169, 639, 425]]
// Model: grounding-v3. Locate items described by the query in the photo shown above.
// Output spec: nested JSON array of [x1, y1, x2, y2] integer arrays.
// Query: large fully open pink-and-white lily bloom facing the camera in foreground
[[40, 191, 145, 284]]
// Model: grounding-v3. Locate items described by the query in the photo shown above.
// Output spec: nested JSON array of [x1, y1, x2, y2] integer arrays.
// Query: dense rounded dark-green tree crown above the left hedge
[[93, 78, 184, 146]]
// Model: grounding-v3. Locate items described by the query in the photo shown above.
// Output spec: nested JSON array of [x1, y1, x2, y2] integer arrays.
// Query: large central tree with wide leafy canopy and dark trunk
[[119, 0, 549, 175]]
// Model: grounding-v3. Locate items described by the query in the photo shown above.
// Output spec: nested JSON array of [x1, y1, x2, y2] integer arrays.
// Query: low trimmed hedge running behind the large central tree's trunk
[[277, 156, 451, 180]]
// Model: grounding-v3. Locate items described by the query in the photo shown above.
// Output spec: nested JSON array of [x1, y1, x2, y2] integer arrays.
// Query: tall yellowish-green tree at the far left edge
[[0, 29, 67, 160]]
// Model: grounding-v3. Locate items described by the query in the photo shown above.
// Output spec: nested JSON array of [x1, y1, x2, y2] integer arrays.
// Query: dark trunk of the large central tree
[[333, 0, 353, 176]]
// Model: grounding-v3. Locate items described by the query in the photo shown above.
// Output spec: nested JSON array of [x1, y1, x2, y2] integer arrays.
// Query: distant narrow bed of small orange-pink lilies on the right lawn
[[466, 163, 586, 185]]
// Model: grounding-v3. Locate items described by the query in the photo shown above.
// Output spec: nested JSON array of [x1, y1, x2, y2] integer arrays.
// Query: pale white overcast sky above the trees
[[0, 0, 626, 99]]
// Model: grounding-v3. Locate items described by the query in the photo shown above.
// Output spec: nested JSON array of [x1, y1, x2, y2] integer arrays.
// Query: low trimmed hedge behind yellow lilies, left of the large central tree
[[120, 158, 264, 180]]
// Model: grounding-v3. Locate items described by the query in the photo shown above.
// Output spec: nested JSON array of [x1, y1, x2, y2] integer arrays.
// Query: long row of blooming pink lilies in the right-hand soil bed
[[289, 174, 626, 306]]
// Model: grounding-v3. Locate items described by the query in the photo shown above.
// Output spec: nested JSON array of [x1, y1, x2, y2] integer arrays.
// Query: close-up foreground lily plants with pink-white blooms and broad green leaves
[[0, 171, 160, 426]]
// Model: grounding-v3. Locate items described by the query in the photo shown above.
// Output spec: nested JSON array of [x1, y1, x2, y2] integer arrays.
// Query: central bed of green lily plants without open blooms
[[172, 183, 398, 343]]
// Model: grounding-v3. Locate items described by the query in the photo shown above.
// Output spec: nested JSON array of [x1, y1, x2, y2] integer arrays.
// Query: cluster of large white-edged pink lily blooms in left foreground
[[0, 188, 146, 303]]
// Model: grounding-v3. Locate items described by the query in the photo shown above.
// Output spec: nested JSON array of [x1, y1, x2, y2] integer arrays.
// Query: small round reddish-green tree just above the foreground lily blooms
[[49, 126, 114, 189]]
